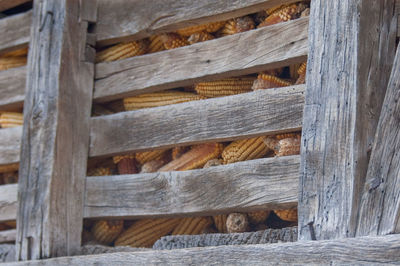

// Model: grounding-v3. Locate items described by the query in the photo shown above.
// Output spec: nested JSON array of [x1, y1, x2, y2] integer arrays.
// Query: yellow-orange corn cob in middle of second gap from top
[[195, 77, 254, 98]]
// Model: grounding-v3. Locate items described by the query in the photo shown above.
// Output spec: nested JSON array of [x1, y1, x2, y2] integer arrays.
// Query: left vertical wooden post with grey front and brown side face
[[16, 0, 96, 260]]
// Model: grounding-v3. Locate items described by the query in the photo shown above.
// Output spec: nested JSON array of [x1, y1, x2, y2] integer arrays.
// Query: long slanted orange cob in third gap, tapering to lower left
[[158, 143, 223, 172]]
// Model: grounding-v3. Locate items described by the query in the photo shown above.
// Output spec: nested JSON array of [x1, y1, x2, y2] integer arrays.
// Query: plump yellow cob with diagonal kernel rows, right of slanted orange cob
[[222, 137, 269, 164]]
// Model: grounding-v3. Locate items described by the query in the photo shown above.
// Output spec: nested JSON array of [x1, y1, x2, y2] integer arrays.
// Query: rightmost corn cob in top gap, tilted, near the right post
[[258, 3, 307, 28]]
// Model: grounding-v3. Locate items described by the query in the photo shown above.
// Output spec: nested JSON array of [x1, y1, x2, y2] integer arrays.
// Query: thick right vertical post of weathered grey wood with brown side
[[299, 0, 396, 240]]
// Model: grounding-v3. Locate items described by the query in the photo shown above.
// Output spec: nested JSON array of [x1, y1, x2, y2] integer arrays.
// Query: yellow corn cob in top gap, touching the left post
[[96, 40, 148, 63]]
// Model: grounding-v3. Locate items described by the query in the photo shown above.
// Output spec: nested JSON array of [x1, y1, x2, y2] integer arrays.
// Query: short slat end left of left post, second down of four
[[0, 67, 26, 111]]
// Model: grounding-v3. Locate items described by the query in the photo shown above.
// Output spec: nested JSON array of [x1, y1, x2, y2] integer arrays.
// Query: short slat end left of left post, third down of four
[[0, 127, 22, 165]]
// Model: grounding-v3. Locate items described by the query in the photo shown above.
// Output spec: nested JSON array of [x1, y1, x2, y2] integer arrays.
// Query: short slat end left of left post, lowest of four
[[0, 184, 18, 221]]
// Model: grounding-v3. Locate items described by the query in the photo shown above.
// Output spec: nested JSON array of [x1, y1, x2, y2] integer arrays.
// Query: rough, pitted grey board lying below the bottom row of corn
[[153, 227, 298, 250]]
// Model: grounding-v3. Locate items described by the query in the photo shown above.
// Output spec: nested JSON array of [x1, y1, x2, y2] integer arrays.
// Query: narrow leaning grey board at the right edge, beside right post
[[357, 46, 400, 235]]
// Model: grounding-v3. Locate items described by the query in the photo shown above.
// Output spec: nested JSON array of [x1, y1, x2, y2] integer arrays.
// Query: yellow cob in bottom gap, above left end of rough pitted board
[[171, 217, 212, 235]]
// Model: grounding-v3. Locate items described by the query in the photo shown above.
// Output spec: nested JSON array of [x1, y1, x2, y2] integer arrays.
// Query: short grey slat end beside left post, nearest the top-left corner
[[0, 11, 32, 53]]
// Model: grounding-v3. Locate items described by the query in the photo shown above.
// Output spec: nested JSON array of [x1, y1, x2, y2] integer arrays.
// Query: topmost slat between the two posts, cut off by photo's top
[[96, 0, 304, 45]]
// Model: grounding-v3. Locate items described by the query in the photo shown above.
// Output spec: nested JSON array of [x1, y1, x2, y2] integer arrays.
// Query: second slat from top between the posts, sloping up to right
[[94, 18, 308, 101]]
